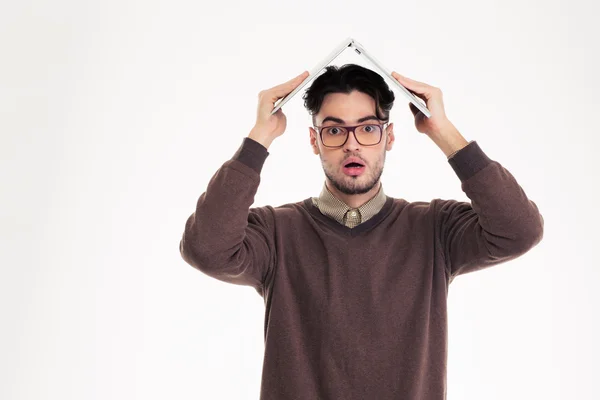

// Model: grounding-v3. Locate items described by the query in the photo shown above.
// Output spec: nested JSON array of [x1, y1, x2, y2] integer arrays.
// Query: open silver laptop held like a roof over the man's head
[[271, 37, 431, 118]]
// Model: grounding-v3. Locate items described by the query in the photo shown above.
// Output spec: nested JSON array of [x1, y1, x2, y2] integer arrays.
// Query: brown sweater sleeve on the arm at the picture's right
[[434, 141, 544, 281]]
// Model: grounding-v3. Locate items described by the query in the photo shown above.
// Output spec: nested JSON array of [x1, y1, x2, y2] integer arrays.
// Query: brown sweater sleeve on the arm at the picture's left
[[179, 138, 275, 295]]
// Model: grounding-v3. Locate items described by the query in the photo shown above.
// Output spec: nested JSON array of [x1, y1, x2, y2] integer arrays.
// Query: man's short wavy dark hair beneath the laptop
[[302, 64, 395, 125]]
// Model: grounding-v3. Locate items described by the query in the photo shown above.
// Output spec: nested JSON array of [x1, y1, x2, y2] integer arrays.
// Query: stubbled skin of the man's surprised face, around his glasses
[[309, 90, 394, 195]]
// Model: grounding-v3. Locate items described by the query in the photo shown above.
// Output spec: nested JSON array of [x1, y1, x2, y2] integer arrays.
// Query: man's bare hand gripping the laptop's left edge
[[248, 71, 308, 148]]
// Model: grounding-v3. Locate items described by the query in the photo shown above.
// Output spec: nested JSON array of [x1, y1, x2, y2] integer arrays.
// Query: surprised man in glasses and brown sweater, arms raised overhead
[[180, 64, 544, 400]]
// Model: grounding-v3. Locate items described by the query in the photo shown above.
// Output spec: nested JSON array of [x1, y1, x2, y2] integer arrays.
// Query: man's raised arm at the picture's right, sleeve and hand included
[[392, 71, 544, 281]]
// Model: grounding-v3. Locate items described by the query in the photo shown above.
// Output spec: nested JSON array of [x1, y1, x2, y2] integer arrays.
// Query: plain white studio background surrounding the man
[[0, 0, 600, 400]]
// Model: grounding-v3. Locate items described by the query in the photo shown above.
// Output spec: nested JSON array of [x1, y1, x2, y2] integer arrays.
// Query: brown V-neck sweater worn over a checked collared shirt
[[180, 138, 544, 400]]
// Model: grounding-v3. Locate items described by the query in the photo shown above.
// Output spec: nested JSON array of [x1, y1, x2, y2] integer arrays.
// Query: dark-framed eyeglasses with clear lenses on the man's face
[[315, 122, 388, 147]]
